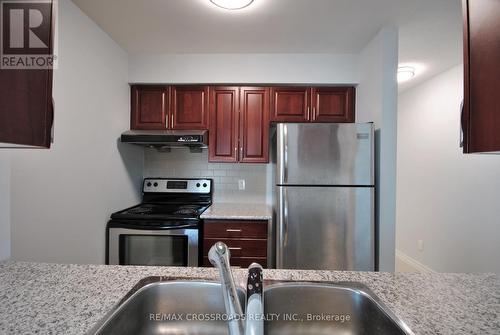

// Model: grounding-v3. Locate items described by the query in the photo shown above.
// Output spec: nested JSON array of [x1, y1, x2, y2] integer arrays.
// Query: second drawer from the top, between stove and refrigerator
[[203, 238, 267, 259]]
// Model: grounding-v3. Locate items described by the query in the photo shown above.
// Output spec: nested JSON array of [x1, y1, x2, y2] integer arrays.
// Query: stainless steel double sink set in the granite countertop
[[90, 277, 413, 335]]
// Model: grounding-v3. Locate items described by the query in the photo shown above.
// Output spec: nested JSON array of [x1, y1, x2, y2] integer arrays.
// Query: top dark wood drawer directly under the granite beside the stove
[[203, 220, 267, 239]]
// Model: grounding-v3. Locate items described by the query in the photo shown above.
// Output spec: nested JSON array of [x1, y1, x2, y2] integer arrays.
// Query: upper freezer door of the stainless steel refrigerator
[[276, 123, 374, 185]]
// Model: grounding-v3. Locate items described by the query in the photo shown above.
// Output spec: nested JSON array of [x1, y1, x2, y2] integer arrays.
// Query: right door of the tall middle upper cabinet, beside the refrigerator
[[240, 87, 269, 163]]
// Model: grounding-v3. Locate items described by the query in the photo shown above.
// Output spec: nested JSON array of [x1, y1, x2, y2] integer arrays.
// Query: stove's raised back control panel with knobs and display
[[142, 178, 212, 194]]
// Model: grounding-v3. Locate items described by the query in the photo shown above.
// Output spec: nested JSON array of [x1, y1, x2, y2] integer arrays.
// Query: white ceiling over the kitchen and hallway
[[73, 0, 461, 89]]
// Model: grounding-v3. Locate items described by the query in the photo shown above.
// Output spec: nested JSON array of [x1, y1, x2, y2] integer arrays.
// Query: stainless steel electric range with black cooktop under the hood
[[106, 178, 212, 266]]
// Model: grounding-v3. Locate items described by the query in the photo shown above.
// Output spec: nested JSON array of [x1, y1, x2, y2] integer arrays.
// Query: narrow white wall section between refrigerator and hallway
[[356, 27, 398, 271]]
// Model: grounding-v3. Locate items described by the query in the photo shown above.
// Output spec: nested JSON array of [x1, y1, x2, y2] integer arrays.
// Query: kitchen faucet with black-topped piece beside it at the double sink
[[208, 242, 264, 335]]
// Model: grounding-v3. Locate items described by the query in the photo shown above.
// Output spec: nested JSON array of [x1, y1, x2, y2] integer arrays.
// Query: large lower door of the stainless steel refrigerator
[[276, 186, 375, 271]]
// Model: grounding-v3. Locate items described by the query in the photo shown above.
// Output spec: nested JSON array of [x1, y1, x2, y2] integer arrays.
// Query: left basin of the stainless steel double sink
[[90, 279, 245, 335]]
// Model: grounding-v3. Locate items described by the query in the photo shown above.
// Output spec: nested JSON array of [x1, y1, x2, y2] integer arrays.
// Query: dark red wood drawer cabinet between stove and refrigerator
[[203, 220, 268, 267]]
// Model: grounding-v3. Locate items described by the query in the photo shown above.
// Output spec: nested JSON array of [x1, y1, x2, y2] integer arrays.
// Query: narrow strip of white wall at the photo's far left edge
[[0, 154, 10, 261]]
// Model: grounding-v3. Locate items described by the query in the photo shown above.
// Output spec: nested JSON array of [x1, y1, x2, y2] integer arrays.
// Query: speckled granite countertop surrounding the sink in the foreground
[[0, 262, 500, 335]]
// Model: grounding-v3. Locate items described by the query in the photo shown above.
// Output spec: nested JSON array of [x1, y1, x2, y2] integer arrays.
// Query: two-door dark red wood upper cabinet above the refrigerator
[[271, 86, 356, 122]]
